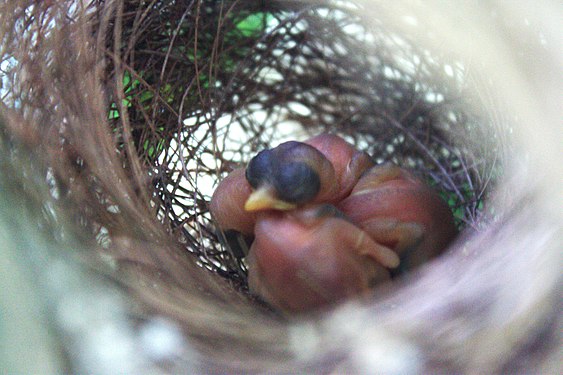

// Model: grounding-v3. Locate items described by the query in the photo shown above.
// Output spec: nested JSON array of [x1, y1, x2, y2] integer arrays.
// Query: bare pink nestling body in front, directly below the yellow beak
[[247, 204, 399, 313]]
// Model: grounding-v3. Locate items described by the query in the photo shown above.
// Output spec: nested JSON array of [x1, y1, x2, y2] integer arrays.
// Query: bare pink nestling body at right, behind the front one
[[337, 164, 457, 271]]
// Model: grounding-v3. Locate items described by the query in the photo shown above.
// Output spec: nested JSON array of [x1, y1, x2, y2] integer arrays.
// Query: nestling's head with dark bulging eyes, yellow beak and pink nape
[[245, 134, 373, 211]]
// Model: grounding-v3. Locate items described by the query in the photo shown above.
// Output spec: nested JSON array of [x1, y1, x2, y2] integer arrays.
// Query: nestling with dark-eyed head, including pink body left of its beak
[[209, 134, 373, 235]]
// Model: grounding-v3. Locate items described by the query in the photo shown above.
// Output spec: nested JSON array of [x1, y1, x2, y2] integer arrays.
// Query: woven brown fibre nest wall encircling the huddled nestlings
[[0, 1, 560, 372]]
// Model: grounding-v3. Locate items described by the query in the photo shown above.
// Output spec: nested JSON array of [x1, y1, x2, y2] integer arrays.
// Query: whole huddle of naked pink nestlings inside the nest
[[210, 134, 456, 312]]
